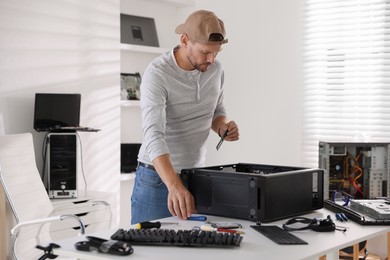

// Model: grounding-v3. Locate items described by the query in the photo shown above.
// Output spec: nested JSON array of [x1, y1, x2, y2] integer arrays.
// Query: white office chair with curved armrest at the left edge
[[0, 133, 85, 259]]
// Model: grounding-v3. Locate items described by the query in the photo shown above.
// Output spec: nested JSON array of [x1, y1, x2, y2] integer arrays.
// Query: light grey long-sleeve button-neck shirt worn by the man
[[138, 46, 226, 172]]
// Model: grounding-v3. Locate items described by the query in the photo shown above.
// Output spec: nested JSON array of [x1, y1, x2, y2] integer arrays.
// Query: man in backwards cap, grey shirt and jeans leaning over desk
[[131, 10, 239, 224]]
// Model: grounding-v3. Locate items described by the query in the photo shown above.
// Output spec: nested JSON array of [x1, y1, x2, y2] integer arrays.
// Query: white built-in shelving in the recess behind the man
[[120, 0, 195, 226]]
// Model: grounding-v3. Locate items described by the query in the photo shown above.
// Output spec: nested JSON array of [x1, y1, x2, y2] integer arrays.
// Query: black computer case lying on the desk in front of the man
[[180, 163, 324, 222]]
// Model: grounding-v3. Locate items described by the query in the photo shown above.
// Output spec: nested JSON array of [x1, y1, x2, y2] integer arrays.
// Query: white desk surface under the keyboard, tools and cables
[[54, 209, 390, 260]]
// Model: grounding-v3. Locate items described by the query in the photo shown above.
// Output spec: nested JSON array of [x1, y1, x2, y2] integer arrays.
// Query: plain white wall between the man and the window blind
[[196, 0, 303, 166]]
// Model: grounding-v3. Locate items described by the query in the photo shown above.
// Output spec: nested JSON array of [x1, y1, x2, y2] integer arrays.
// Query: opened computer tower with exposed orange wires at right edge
[[318, 141, 390, 199]]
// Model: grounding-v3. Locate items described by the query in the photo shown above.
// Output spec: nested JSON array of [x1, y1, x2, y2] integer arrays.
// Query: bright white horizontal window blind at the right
[[302, 0, 390, 167]]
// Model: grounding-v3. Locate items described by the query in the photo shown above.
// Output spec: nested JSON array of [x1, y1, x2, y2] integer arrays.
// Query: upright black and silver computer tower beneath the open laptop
[[47, 133, 77, 199]]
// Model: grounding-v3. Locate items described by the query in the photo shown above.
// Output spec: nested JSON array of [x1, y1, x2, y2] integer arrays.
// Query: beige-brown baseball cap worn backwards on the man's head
[[175, 10, 228, 45]]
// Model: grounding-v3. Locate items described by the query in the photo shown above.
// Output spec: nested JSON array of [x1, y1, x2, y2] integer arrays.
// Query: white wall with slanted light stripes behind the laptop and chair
[[0, 0, 120, 211]]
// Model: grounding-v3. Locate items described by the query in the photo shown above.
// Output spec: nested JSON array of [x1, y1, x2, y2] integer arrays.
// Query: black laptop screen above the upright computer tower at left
[[34, 93, 81, 132]]
